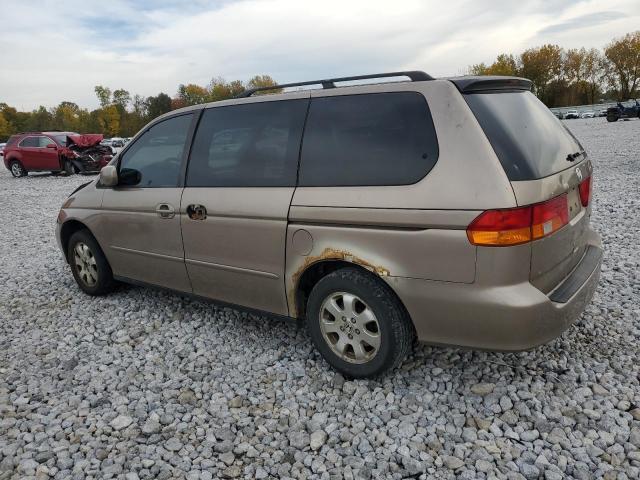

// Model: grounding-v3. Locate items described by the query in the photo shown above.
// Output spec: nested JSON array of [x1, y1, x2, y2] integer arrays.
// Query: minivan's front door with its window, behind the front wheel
[[96, 113, 194, 292]]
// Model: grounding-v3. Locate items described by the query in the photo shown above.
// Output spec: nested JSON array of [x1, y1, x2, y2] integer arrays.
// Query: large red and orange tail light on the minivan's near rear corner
[[467, 193, 569, 247]]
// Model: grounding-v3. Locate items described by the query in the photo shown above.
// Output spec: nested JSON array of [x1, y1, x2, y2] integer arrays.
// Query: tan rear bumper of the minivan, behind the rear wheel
[[387, 232, 602, 350]]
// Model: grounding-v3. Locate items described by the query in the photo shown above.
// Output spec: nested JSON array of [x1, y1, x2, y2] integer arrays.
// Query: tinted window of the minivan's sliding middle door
[[187, 100, 308, 187]]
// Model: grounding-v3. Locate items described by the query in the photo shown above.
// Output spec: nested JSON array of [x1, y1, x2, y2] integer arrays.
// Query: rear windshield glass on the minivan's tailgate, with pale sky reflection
[[465, 92, 583, 181]]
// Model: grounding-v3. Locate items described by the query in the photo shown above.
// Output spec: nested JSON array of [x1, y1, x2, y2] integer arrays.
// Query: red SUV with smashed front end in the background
[[4, 132, 112, 177]]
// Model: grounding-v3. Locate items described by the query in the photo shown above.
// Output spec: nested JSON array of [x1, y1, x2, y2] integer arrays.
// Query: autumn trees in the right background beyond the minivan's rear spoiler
[[469, 30, 640, 107]]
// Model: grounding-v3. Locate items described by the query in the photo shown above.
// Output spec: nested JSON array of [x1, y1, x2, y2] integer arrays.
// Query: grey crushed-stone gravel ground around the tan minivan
[[0, 119, 640, 480]]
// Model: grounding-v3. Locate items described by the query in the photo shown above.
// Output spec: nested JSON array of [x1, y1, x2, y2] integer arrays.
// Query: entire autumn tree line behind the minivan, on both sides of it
[[0, 30, 640, 141]]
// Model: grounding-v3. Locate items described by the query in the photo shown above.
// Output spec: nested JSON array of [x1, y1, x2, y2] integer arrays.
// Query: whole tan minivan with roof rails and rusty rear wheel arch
[[57, 72, 602, 377]]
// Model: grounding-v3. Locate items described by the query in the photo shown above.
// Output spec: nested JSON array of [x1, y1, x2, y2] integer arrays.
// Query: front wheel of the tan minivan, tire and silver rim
[[67, 230, 115, 296]]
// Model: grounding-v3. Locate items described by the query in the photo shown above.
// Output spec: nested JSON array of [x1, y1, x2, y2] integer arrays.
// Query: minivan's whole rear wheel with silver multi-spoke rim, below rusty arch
[[306, 267, 414, 378]]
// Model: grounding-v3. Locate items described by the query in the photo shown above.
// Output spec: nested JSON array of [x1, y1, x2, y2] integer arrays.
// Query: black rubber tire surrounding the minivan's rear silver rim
[[306, 267, 414, 378]]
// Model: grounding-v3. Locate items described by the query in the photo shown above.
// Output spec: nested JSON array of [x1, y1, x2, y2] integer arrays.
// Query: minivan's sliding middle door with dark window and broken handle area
[[180, 92, 309, 315]]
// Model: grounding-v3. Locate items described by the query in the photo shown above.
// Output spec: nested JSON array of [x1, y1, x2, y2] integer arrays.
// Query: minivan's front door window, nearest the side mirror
[[120, 114, 193, 187]]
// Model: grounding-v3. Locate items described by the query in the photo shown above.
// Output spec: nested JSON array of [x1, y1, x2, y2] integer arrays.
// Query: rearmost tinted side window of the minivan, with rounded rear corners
[[299, 92, 438, 186]]
